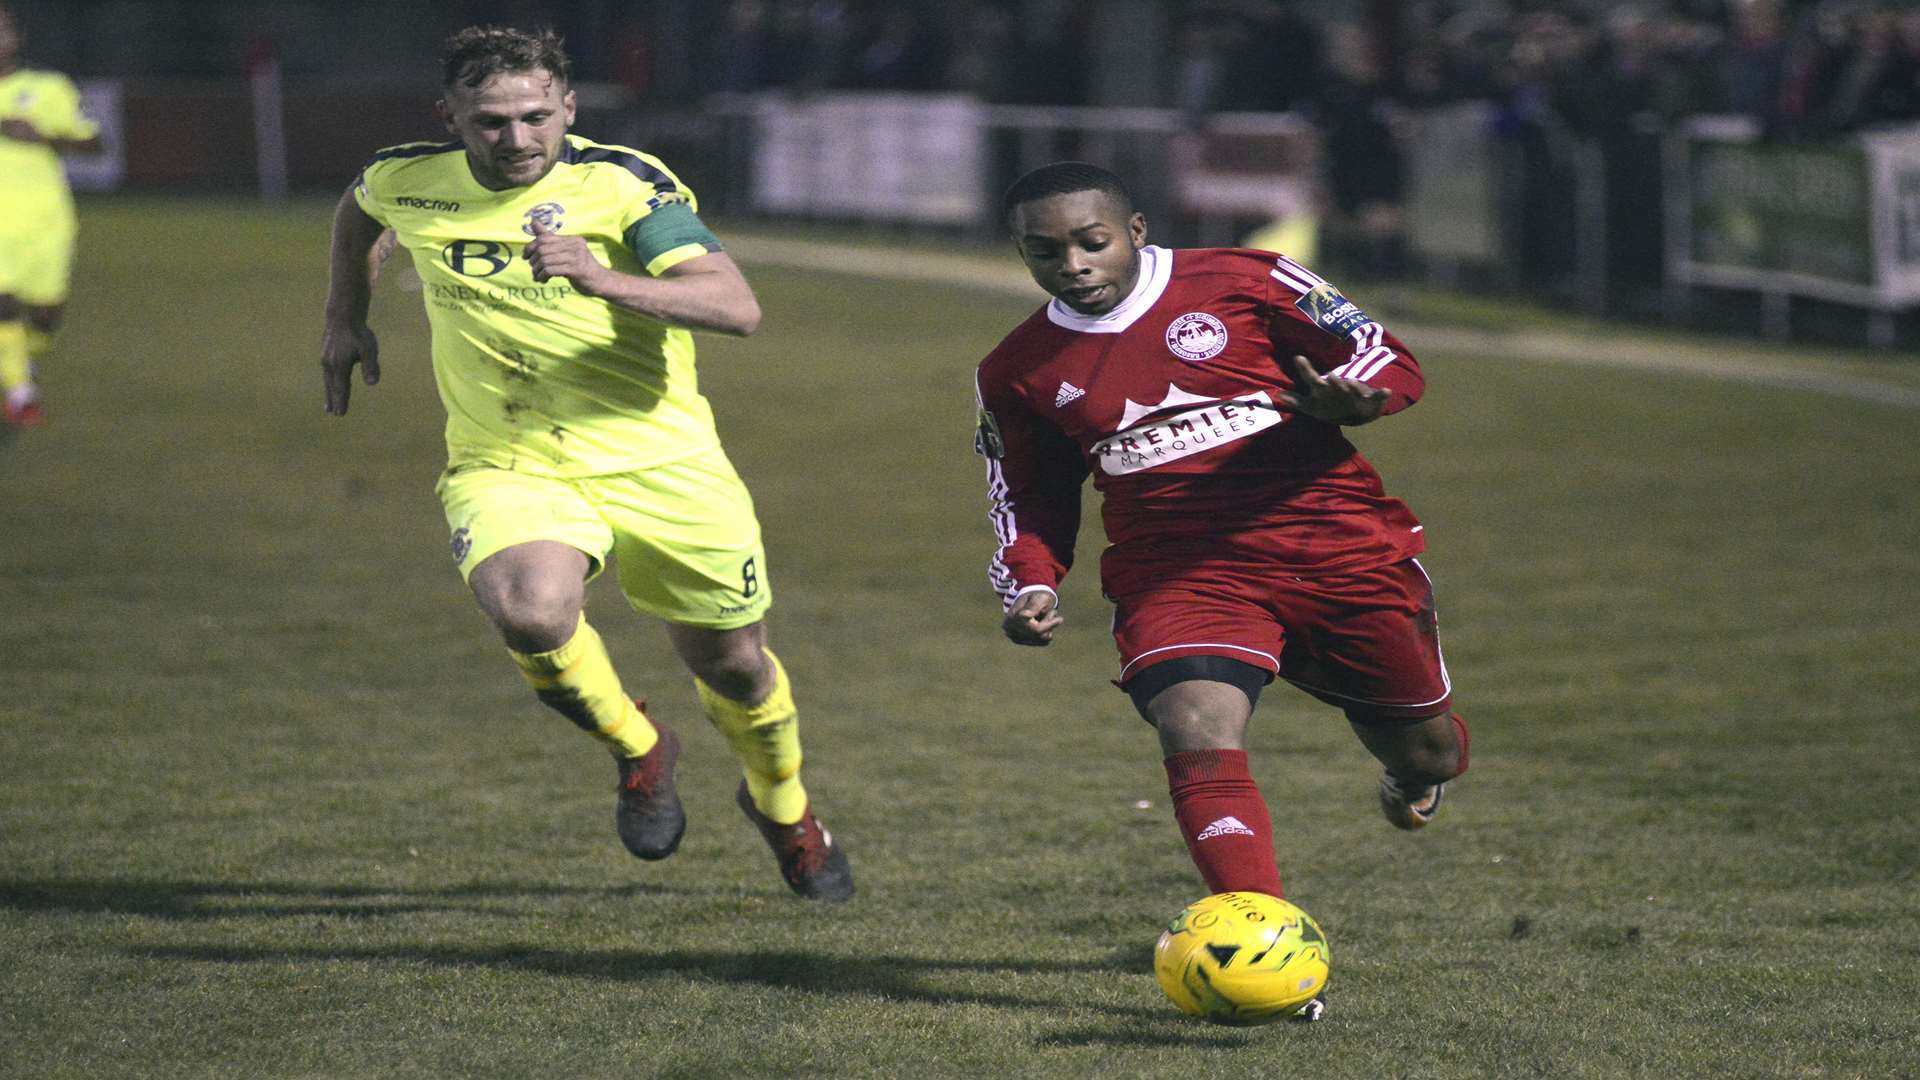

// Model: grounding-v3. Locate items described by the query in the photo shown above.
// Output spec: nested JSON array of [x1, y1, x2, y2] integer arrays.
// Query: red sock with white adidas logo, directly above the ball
[[1165, 749, 1286, 896]]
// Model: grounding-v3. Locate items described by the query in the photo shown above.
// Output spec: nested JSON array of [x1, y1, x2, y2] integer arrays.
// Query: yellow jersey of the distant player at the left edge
[[0, 67, 100, 229]]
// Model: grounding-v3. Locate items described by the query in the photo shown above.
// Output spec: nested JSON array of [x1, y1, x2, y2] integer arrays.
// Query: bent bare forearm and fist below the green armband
[[526, 221, 760, 338]]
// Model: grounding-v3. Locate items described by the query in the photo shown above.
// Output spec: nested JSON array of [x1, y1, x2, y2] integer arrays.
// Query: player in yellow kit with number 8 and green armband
[[321, 27, 852, 899]]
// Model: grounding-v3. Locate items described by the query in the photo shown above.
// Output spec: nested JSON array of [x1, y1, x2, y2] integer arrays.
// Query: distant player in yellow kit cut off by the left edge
[[0, 4, 100, 427]]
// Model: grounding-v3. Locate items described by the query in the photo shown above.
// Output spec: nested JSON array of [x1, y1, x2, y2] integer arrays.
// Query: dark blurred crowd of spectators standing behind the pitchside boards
[[718, 0, 1920, 286]]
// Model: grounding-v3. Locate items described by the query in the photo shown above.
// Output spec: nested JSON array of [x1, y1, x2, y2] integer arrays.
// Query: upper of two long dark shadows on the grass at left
[[0, 878, 684, 920]]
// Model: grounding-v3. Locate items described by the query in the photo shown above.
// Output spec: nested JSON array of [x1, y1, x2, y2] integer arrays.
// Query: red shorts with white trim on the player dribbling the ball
[[1114, 559, 1452, 719]]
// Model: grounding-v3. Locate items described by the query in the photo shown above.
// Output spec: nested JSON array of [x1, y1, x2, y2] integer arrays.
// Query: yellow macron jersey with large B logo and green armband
[[353, 135, 720, 477]]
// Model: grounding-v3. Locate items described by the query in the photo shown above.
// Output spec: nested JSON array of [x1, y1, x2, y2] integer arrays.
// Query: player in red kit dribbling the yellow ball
[[975, 161, 1467, 910]]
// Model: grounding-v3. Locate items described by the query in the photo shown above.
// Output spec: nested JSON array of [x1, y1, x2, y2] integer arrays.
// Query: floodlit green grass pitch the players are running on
[[0, 202, 1920, 1078]]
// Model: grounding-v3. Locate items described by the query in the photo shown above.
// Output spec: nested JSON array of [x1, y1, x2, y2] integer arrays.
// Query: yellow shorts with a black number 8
[[436, 446, 774, 630]]
